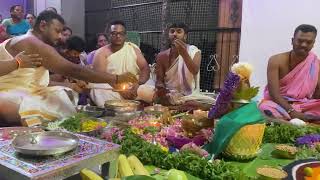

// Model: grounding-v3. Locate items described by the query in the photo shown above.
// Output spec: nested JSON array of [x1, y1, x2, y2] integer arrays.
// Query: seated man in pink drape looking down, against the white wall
[[259, 24, 320, 121]]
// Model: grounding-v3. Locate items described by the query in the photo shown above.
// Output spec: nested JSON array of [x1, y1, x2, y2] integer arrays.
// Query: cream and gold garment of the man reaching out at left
[[0, 39, 75, 121]]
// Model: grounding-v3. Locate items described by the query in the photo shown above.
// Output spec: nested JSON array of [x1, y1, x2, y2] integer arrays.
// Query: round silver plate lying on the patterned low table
[[12, 131, 79, 156]]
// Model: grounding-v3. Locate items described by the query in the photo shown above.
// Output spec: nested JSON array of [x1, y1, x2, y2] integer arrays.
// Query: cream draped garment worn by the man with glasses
[[90, 42, 154, 107]]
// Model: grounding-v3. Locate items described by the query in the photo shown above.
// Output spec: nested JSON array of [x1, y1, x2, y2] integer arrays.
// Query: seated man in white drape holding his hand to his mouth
[[155, 23, 201, 105]]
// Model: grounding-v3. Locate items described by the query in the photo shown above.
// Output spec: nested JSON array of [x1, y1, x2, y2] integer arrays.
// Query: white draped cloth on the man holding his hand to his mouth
[[165, 45, 200, 104]]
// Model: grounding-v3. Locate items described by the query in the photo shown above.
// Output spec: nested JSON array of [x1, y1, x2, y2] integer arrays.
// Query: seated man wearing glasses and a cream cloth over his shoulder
[[90, 21, 150, 107]]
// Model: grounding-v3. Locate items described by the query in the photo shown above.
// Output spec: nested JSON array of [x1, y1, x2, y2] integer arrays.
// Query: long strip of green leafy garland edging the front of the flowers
[[120, 130, 244, 180]]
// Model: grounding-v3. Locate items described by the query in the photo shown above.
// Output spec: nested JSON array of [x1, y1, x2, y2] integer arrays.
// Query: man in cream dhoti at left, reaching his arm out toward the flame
[[0, 11, 136, 123]]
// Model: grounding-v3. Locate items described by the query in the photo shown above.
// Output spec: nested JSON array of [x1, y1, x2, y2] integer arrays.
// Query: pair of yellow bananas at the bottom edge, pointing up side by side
[[117, 154, 150, 178]]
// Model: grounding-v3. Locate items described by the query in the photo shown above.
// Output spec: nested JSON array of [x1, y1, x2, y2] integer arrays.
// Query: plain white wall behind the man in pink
[[239, 0, 320, 96]]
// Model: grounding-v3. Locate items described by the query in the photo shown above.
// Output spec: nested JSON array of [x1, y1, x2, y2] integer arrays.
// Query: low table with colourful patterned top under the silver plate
[[0, 128, 120, 180]]
